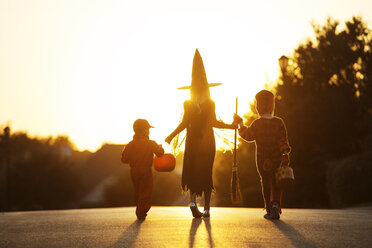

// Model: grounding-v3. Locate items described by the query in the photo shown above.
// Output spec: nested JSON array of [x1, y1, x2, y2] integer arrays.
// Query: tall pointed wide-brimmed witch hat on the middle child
[[177, 48, 222, 90]]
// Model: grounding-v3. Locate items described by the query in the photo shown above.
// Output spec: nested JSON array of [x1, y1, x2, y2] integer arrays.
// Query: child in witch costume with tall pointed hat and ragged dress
[[165, 49, 237, 218]]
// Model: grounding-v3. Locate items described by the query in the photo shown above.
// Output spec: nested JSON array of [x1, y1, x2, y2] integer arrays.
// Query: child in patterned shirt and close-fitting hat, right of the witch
[[234, 90, 291, 219]]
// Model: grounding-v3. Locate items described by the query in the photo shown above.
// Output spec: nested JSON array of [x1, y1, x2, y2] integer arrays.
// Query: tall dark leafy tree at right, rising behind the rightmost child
[[276, 17, 372, 206]]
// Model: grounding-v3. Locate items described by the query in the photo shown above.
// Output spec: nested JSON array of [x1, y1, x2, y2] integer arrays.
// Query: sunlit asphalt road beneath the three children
[[0, 207, 372, 248]]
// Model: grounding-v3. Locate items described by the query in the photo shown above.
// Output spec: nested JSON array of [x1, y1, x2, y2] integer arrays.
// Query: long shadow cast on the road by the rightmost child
[[271, 220, 317, 248]]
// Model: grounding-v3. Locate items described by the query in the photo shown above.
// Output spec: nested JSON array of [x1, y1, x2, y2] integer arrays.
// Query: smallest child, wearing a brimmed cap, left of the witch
[[121, 119, 164, 219]]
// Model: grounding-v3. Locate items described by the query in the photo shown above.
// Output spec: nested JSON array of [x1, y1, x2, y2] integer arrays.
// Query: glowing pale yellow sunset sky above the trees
[[0, 0, 372, 151]]
